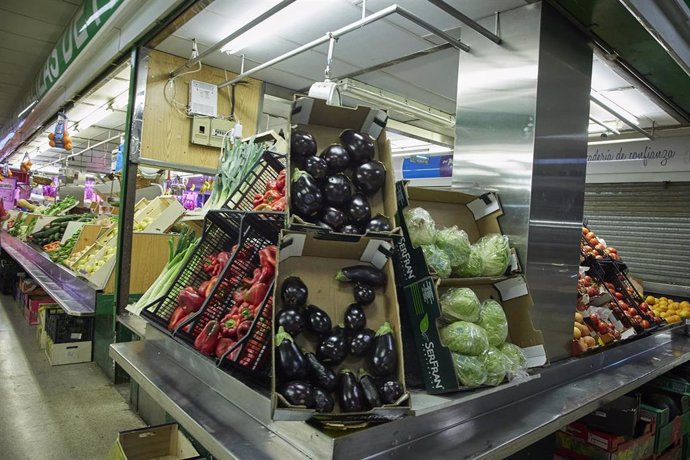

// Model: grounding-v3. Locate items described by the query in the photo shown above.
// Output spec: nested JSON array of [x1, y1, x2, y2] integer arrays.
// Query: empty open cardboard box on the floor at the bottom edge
[[108, 423, 202, 460]]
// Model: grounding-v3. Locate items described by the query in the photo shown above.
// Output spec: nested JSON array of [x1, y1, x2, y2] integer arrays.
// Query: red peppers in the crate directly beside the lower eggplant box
[[194, 246, 276, 366]]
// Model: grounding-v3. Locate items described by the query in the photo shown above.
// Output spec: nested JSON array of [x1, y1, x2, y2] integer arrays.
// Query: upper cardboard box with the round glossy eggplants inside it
[[286, 97, 399, 241]]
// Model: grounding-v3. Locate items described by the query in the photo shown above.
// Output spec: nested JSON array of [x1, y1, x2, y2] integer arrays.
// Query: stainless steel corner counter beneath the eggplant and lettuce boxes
[[110, 328, 690, 459]]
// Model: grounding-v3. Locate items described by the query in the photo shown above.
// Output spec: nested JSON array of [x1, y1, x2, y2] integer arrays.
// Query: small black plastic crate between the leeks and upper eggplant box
[[223, 150, 286, 211]]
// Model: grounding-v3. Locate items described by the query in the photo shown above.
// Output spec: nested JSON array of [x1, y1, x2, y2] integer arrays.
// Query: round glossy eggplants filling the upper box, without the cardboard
[[290, 129, 392, 234]]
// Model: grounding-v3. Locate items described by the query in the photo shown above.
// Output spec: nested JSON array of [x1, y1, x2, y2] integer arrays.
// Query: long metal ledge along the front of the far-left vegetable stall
[[0, 232, 97, 316]]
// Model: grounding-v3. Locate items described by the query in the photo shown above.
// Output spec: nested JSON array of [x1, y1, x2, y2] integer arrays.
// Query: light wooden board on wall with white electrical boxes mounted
[[141, 50, 261, 169]]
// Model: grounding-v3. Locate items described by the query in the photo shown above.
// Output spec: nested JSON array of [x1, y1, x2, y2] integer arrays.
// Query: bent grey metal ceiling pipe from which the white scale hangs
[[218, 5, 470, 88]]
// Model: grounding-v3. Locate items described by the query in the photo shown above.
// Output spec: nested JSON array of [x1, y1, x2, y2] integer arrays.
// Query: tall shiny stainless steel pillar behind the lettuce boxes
[[453, 3, 592, 362]]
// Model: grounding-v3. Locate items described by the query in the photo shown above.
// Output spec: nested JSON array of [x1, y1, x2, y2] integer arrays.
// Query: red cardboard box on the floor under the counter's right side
[[556, 421, 654, 460]]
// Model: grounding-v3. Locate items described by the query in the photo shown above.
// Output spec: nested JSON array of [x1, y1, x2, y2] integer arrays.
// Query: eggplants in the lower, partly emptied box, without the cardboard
[[274, 265, 403, 413]]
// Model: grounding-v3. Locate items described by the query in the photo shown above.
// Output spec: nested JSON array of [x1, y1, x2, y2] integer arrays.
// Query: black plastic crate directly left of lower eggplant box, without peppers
[[174, 211, 285, 377]]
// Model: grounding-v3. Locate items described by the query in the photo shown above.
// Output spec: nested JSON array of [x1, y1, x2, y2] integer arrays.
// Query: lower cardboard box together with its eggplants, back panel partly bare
[[272, 230, 410, 428]]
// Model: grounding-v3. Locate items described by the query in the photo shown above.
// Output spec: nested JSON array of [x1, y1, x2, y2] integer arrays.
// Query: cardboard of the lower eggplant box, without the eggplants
[[272, 230, 410, 427]]
